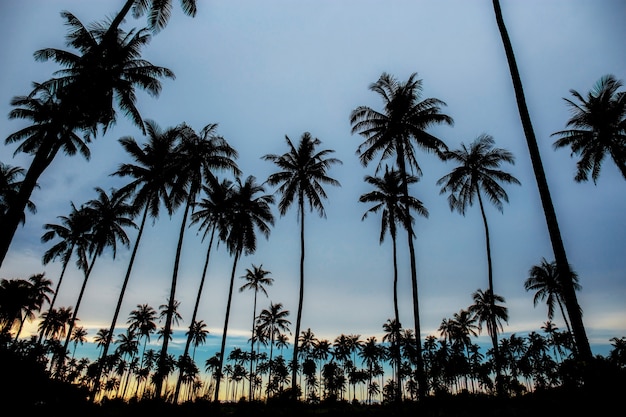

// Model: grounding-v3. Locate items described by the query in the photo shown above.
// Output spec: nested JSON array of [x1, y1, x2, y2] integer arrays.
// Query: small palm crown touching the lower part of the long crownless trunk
[[524, 258, 582, 333]]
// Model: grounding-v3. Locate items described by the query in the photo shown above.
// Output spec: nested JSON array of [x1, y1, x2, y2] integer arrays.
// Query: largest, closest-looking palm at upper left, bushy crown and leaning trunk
[[0, 12, 174, 265]]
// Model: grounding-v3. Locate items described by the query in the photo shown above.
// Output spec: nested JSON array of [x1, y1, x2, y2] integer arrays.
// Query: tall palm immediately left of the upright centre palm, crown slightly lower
[[214, 175, 274, 402]]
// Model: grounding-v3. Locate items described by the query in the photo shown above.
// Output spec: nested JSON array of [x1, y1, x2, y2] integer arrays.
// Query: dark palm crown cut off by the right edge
[[552, 74, 626, 184]]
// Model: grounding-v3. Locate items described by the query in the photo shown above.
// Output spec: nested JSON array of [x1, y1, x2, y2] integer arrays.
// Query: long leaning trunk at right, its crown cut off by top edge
[[493, 0, 593, 361]]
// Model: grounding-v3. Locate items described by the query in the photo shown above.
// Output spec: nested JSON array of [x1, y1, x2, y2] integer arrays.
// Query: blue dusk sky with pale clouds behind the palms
[[0, 0, 626, 358]]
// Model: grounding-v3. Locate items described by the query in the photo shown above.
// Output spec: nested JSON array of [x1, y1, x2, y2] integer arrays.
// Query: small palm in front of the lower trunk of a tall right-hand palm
[[468, 289, 509, 392]]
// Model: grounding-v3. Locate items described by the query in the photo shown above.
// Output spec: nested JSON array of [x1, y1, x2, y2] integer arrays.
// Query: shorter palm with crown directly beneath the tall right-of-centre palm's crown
[[359, 166, 428, 332]]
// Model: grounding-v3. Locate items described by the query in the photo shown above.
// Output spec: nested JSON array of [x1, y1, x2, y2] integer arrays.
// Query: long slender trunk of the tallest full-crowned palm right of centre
[[396, 146, 428, 398]]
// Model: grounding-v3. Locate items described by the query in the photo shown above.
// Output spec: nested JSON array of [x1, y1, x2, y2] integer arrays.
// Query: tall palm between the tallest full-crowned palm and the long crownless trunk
[[437, 134, 520, 386]]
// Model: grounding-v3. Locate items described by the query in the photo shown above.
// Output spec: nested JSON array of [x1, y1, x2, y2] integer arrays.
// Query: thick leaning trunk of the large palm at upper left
[[0, 141, 59, 267]]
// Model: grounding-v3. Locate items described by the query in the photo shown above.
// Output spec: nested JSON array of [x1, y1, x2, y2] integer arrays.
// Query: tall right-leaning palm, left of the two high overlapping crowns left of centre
[[90, 120, 179, 401]]
